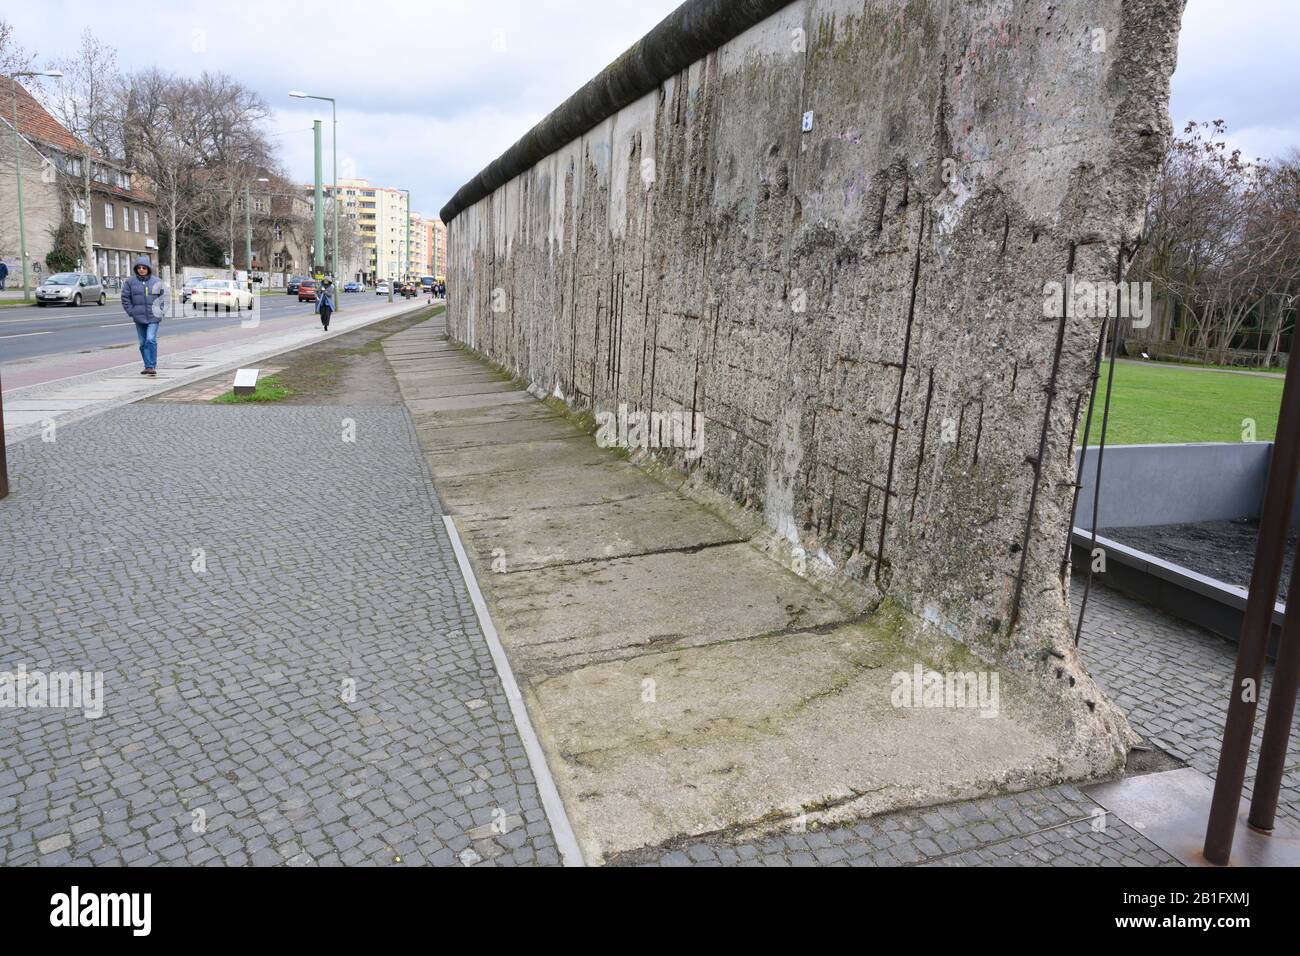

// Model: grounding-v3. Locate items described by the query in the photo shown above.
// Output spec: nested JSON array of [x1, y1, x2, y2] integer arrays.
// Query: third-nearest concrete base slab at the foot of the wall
[[462, 490, 741, 574]]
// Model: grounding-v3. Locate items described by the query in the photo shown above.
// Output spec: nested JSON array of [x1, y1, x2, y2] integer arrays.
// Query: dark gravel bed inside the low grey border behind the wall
[[1097, 518, 1296, 590]]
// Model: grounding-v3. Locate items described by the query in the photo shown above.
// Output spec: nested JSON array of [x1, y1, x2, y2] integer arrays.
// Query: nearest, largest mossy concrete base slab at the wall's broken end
[[529, 616, 1053, 861]]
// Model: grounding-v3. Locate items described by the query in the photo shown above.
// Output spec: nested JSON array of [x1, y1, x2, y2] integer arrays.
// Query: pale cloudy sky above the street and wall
[[0, 0, 1300, 216]]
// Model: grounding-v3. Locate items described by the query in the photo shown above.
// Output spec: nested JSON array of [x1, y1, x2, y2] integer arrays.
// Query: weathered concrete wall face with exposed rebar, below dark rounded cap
[[449, 0, 1182, 691]]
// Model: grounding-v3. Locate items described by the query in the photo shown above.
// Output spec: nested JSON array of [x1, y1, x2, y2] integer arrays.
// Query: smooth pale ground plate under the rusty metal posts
[[1083, 767, 1300, 866]]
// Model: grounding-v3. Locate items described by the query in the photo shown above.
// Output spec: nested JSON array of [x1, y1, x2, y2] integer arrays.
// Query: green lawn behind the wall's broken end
[[1076, 362, 1282, 445]]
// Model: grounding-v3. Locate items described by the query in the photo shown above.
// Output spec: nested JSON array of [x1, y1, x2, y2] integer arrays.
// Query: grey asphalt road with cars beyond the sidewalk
[[0, 293, 390, 364]]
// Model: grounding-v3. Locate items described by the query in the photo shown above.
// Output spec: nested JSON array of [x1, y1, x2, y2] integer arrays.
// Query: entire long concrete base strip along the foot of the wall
[[384, 320, 1071, 864]]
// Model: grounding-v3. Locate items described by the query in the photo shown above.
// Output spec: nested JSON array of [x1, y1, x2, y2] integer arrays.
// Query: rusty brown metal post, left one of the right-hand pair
[[1205, 349, 1300, 866]]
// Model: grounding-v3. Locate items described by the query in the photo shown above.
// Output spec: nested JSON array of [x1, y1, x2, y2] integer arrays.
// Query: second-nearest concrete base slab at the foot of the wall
[[489, 544, 849, 675]]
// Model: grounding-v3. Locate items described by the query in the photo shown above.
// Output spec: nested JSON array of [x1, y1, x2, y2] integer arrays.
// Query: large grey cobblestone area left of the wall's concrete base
[[0, 406, 558, 865]]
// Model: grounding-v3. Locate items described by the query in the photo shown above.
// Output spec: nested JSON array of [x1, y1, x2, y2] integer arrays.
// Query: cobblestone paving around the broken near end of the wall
[[608, 585, 1300, 866]]
